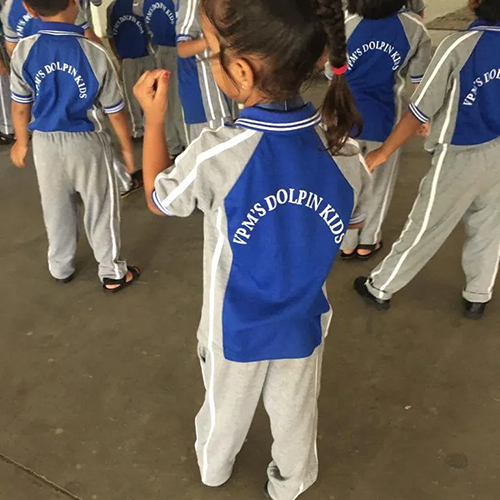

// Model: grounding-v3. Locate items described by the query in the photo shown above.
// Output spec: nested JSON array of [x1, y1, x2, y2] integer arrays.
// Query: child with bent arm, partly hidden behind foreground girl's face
[[177, 0, 235, 141]]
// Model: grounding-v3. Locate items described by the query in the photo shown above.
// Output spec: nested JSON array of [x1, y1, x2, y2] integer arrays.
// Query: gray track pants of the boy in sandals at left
[[33, 132, 127, 280]]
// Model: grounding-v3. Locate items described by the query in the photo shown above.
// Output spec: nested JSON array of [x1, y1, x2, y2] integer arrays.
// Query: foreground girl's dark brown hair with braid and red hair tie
[[202, 0, 361, 154]]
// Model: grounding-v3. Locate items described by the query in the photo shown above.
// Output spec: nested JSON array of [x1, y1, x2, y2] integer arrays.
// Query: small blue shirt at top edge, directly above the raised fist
[[143, 0, 176, 47]]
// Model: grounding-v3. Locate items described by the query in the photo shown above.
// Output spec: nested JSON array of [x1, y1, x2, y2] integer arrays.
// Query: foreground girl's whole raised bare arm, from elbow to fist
[[134, 69, 172, 215]]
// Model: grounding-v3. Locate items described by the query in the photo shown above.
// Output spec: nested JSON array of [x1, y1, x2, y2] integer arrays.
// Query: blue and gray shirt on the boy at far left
[[11, 22, 124, 132]]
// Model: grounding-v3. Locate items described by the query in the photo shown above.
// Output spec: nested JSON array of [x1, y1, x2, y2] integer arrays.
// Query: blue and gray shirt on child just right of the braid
[[346, 12, 431, 142]]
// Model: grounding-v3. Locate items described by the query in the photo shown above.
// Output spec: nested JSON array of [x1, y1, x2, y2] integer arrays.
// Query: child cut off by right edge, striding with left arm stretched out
[[355, 0, 500, 319]]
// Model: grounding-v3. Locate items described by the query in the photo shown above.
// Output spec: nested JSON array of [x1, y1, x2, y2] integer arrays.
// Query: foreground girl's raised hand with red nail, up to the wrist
[[134, 69, 170, 122]]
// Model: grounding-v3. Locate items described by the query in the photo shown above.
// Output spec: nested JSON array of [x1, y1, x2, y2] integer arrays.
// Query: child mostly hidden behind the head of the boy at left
[[2, 0, 99, 57]]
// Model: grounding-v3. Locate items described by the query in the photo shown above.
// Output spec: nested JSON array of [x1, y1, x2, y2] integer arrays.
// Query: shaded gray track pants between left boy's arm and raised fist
[[122, 56, 155, 137]]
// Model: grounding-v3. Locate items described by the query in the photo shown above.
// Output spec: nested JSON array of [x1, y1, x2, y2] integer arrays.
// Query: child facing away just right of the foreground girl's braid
[[327, 0, 432, 260]]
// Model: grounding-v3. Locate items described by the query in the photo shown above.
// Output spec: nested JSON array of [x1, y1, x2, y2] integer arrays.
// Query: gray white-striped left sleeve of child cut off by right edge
[[410, 32, 473, 123]]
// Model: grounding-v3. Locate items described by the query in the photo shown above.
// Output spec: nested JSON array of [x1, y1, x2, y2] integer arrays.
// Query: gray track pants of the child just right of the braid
[[342, 141, 400, 251]]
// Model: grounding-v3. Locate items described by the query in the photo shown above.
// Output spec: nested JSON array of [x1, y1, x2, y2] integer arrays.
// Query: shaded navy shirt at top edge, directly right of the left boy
[[108, 0, 149, 59]]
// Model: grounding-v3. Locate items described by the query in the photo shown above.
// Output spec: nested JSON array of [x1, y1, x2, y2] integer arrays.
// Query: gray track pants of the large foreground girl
[[196, 344, 323, 500]]
